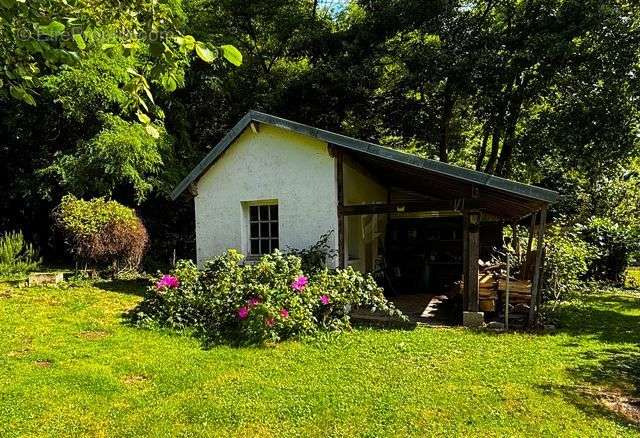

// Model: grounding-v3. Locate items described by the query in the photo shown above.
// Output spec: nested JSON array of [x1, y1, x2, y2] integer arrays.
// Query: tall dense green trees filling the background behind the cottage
[[0, 0, 640, 280]]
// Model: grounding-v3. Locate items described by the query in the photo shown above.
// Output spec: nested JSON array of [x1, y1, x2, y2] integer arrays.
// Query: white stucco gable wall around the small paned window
[[195, 125, 338, 265]]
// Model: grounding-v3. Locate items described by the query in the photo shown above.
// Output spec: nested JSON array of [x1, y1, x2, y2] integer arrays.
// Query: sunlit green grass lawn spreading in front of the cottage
[[0, 283, 640, 437]]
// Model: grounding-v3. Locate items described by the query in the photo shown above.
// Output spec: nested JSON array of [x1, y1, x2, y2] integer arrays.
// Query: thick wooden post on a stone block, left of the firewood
[[463, 210, 480, 312]]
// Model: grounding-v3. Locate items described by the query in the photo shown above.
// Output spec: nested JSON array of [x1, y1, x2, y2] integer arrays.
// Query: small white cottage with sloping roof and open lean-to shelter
[[172, 111, 557, 318]]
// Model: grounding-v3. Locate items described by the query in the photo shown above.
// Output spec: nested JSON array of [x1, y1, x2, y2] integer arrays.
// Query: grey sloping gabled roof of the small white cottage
[[171, 111, 558, 210]]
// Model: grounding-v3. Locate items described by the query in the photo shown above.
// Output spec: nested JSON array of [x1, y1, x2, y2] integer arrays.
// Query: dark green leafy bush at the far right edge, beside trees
[[582, 217, 640, 286]]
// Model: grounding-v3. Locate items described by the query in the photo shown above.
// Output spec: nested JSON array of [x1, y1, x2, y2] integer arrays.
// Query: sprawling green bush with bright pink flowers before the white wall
[[134, 250, 404, 344]]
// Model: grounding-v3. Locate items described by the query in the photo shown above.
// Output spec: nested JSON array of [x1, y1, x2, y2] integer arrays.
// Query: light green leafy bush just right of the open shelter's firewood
[[545, 224, 594, 301]]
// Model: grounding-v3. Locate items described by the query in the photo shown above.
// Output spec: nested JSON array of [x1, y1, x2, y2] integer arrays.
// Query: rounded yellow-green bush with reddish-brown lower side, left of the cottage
[[54, 195, 149, 273]]
